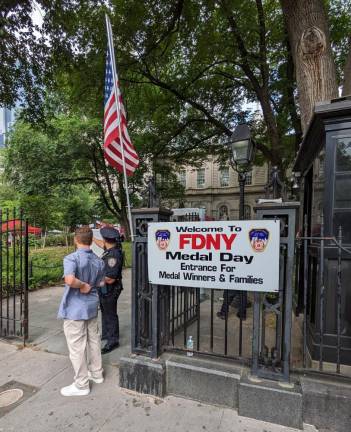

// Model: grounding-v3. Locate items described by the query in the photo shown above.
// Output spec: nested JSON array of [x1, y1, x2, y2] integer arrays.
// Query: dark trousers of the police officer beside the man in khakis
[[100, 289, 121, 345]]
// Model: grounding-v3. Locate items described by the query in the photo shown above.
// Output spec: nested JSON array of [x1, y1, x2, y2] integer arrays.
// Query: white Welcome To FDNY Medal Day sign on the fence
[[148, 220, 280, 292]]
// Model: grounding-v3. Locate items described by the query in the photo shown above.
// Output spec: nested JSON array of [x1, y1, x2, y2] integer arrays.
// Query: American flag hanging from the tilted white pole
[[104, 48, 139, 176]]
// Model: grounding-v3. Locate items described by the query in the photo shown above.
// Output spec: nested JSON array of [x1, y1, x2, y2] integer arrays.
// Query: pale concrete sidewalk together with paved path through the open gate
[[0, 270, 315, 432]]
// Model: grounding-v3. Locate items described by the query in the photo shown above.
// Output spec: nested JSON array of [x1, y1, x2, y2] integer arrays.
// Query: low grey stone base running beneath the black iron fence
[[119, 353, 351, 432]]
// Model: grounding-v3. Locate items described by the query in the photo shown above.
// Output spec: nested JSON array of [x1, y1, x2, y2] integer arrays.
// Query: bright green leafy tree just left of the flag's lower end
[[5, 115, 147, 235]]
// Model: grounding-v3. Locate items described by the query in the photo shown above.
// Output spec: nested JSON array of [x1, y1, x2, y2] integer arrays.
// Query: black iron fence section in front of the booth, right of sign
[[296, 218, 351, 374]]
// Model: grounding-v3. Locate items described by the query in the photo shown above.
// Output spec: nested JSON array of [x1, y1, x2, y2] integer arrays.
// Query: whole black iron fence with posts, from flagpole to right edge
[[132, 208, 351, 380]]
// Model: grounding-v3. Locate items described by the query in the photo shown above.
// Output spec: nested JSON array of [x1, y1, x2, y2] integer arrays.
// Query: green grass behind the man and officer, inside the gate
[[29, 242, 132, 290]]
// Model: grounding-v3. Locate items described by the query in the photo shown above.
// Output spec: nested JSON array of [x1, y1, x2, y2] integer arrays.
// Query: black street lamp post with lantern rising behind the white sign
[[228, 124, 255, 332]]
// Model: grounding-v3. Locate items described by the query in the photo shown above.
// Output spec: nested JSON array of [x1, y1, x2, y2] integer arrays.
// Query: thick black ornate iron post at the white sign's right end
[[252, 202, 299, 381]]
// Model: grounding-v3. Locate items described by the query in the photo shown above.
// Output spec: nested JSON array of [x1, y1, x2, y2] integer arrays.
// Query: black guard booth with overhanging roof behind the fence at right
[[294, 99, 351, 365]]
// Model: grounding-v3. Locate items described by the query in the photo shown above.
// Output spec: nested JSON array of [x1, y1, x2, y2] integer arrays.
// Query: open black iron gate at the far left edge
[[0, 209, 29, 341]]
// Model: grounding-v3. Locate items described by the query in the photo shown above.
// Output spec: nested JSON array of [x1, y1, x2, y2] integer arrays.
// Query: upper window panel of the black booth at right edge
[[333, 136, 351, 243]]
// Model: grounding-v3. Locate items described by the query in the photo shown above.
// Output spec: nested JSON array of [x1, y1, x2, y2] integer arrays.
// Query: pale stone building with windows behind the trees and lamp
[[179, 158, 268, 220]]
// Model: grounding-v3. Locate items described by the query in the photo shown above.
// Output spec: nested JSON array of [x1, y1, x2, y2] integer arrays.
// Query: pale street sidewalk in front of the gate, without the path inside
[[0, 342, 315, 432]]
